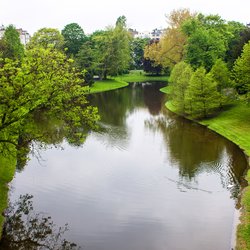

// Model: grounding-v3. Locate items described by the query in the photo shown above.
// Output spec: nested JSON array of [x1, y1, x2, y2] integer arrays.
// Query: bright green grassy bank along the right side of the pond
[[161, 87, 250, 250]]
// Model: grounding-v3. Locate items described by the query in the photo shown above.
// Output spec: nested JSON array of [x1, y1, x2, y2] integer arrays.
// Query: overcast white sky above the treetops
[[0, 0, 250, 34]]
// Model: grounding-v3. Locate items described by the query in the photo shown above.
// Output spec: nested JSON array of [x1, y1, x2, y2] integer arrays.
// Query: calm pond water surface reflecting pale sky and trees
[[6, 83, 246, 250]]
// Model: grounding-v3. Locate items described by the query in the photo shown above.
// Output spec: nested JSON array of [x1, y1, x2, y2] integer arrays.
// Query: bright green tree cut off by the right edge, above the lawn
[[233, 41, 250, 102]]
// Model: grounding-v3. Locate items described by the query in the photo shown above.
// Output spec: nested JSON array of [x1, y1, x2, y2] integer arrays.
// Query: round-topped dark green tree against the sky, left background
[[62, 23, 86, 56]]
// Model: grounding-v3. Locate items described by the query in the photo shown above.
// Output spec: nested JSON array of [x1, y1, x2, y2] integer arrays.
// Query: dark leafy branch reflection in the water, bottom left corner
[[0, 194, 80, 250]]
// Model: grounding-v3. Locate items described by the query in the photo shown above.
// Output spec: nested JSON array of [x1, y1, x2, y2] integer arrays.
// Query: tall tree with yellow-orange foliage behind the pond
[[144, 9, 195, 68]]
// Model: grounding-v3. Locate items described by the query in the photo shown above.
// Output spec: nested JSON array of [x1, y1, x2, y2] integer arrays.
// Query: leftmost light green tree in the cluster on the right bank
[[169, 61, 193, 114]]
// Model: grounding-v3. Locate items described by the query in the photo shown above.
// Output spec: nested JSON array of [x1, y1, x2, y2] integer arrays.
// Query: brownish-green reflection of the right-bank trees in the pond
[[145, 110, 246, 198]]
